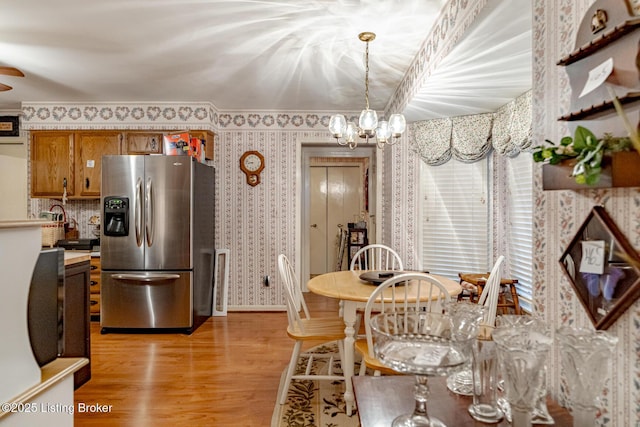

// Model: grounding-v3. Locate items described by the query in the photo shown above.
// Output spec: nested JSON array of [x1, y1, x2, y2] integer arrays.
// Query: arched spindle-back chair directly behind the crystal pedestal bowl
[[355, 273, 451, 376]]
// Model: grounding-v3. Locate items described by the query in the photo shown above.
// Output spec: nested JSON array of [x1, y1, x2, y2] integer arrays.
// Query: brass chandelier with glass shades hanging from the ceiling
[[329, 32, 407, 150]]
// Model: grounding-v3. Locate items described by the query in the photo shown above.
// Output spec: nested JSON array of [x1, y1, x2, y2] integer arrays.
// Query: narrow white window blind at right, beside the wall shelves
[[506, 152, 533, 312]]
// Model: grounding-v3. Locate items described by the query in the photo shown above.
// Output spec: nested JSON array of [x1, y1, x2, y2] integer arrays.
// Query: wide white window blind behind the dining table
[[420, 158, 491, 280]]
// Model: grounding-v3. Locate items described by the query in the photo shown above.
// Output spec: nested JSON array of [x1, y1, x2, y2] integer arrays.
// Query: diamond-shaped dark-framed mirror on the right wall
[[560, 206, 640, 329]]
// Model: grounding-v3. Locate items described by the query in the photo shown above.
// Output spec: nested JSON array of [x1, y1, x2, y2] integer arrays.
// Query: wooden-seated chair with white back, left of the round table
[[278, 254, 345, 404]]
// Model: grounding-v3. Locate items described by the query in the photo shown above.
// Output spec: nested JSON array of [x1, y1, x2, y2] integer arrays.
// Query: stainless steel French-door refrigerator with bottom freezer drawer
[[100, 155, 215, 333]]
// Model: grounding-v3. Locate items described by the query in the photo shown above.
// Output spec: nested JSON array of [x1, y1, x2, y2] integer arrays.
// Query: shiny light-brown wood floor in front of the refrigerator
[[74, 294, 338, 427]]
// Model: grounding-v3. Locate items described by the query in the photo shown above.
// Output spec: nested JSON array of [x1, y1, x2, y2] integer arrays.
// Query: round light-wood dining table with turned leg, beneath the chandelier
[[307, 270, 462, 415]]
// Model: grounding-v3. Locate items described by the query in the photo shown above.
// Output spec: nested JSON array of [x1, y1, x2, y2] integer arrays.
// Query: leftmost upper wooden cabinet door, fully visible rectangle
[[31, 131, 74, 198]]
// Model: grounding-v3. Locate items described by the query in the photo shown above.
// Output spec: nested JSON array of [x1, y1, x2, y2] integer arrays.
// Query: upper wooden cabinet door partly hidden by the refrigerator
[[75, 131, 122, 198]]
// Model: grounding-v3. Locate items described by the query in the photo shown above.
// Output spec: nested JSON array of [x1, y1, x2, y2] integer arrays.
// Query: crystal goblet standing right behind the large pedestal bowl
[[447, 302, 486, 396]]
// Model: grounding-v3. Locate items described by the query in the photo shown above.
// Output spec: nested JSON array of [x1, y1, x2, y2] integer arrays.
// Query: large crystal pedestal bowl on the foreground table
[[371, 311, 469, 427]]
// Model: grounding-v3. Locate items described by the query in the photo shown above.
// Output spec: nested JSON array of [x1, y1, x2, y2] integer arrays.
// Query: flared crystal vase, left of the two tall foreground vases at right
[[493, 325, 553, 427]]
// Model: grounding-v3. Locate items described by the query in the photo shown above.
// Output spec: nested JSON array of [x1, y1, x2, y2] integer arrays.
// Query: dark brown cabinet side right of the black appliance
[[60, 261, 91, 389]]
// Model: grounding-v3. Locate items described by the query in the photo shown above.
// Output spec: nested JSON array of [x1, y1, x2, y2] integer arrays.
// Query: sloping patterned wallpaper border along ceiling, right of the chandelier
[[385, 0, 488, 112]]
